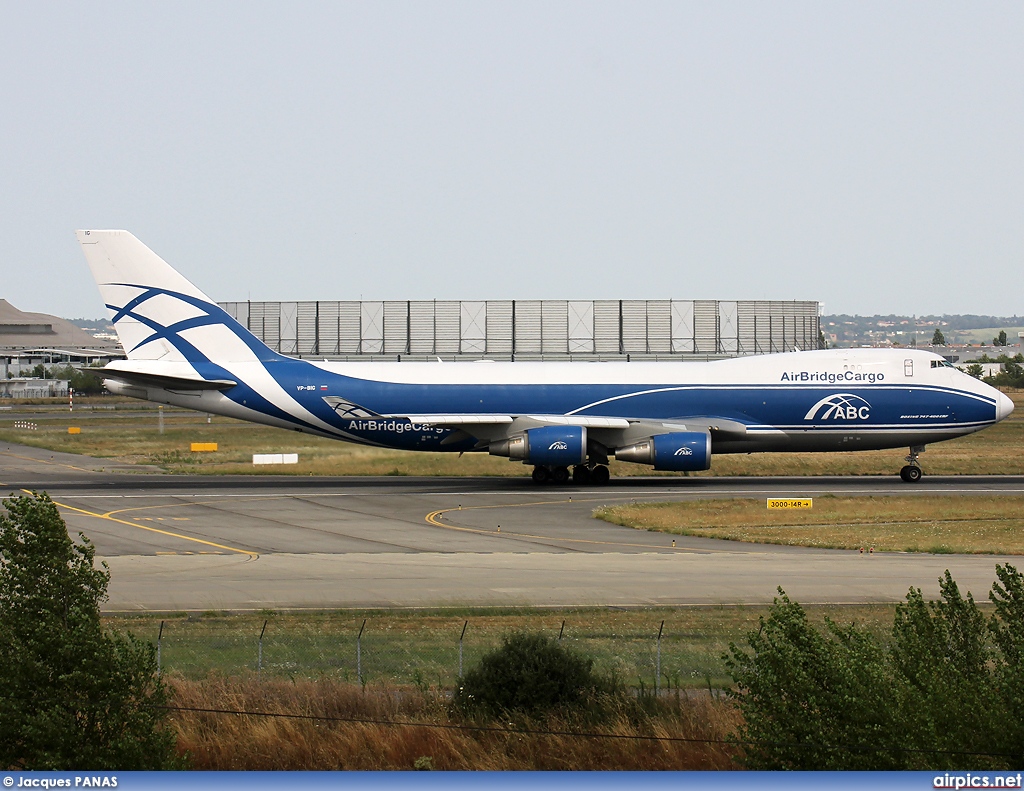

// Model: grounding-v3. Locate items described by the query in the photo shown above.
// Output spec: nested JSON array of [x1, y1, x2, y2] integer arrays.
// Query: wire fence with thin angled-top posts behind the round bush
[[149, 617, 726, 691]]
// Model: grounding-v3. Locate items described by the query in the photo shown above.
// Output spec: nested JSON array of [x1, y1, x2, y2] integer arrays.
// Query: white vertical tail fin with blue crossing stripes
[[76, 231, 281, 365]]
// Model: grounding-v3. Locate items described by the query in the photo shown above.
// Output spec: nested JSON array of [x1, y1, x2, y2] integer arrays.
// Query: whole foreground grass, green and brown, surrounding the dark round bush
[[112, 598, 981, 771]]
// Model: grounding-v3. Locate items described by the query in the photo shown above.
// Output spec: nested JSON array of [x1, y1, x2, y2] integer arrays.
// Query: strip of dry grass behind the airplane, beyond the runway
[[0, 393, 1024, 476]]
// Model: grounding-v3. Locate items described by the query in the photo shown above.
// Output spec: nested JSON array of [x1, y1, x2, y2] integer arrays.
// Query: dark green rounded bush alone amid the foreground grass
[[455, 632, 614, 716]]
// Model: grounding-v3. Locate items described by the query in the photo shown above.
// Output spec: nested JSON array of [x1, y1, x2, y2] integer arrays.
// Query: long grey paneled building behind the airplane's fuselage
[[220, 299, 822, 362]]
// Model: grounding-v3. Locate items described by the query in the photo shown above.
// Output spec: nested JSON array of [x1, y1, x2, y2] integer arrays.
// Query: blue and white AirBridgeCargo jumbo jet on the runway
[[77, 231, 1014, 485]]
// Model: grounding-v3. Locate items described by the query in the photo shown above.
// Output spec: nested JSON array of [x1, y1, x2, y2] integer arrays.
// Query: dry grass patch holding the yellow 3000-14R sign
[[595, 495, 1024, 554]]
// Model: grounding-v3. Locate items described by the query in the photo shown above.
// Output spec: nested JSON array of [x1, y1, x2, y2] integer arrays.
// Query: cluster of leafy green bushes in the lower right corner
[[725, 566, 1024, 769]]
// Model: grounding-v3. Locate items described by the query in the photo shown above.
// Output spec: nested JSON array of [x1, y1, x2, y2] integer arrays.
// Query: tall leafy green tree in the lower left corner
[[0, 493, 178, 769]]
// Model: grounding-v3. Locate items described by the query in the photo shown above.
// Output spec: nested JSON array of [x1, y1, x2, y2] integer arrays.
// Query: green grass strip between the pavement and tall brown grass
[[104, 602, 905, 690]]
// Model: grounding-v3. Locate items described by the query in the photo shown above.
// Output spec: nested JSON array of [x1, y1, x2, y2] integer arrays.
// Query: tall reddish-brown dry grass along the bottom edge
[[170, 676, 738, 769]]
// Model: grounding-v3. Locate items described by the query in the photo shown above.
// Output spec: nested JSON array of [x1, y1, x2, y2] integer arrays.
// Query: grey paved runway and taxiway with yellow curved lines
[[0, 444, 1024, 611]]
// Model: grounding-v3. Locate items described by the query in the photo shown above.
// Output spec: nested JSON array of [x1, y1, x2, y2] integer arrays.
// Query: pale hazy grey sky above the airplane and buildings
[[0, 0, 1024, 317]]
